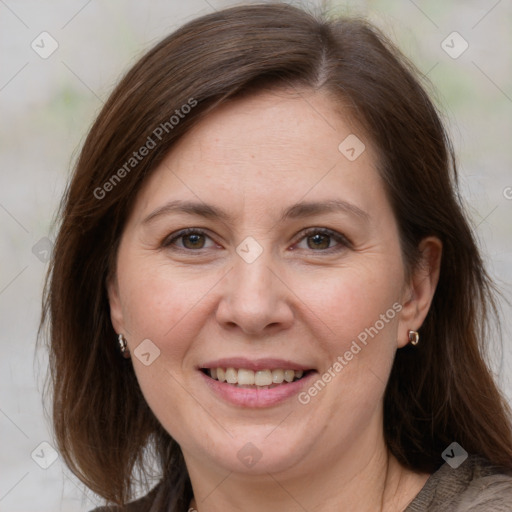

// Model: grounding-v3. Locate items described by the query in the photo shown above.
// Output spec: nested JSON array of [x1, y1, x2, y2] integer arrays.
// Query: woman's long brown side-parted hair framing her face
[[41, 4, 512, 510]]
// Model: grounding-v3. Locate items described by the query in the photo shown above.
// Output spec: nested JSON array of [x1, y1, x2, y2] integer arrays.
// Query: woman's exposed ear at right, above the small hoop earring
[[398, 236, 443, 348]]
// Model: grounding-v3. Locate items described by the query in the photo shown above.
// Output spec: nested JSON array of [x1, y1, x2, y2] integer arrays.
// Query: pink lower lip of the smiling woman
[[199, 371, 317, 409]]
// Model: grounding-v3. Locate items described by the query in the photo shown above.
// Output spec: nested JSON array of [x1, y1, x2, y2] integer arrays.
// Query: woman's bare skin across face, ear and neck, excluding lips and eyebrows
[[108, 91, 441, 512]]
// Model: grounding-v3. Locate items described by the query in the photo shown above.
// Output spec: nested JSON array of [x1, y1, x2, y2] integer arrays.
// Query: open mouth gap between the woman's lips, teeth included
[[200, 366, 315, 389]]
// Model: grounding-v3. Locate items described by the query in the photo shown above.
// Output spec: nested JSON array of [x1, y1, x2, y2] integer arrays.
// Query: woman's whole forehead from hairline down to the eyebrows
[[129, 87, 382, 222]]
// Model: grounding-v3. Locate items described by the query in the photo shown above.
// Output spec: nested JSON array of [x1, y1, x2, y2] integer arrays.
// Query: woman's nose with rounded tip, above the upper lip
[[216, 251, 294, 336]]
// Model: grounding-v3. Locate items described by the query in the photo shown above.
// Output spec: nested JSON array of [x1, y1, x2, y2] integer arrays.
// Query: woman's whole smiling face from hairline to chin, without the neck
[[109, 92, 432, 480]]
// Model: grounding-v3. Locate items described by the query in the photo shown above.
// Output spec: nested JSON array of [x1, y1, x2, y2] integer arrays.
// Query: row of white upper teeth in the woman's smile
[[208, 368, 304, 386]]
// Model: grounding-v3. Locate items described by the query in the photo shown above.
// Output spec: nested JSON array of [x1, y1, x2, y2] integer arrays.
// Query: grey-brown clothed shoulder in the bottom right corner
[[406, 455, 512, 512]]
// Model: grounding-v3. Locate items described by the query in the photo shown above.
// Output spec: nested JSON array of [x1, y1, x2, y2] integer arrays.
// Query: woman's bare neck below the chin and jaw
[[185, 430, 429, 512]]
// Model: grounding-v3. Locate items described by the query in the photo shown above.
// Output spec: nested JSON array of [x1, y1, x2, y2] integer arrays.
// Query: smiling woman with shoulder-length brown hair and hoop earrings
[[43, 4, 512, 512]]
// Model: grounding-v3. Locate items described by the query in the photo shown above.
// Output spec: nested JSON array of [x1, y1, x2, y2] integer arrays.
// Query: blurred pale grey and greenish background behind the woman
[[0, 0, 512, 512]]
